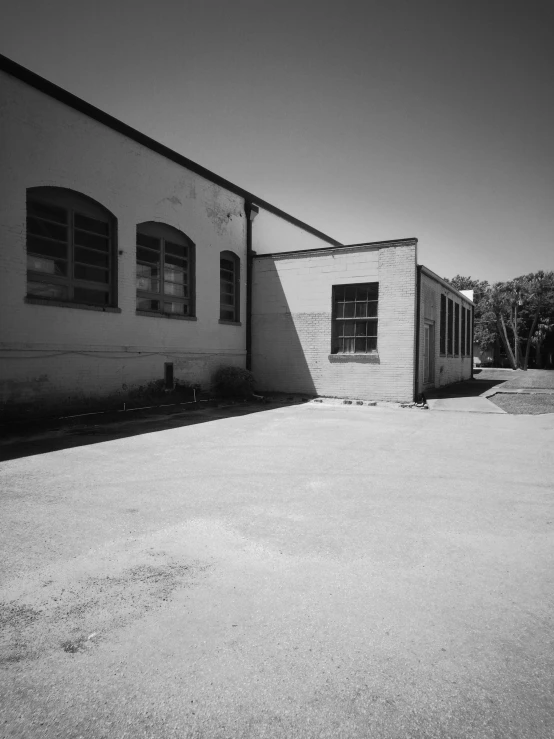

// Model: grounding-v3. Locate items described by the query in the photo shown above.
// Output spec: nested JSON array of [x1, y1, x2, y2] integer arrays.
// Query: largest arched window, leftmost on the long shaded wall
[[27, 187, 117, 307]]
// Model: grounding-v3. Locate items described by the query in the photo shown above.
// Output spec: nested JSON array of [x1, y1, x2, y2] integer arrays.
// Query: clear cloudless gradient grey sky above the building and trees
[[0, 0, 554, 281]]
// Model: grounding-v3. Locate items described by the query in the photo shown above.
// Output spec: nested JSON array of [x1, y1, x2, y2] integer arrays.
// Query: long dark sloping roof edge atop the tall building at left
[[0, 54, 341, 246]]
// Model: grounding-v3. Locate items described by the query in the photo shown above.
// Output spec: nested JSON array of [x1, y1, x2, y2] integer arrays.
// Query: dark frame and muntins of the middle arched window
[[135, 221, 196, 320]]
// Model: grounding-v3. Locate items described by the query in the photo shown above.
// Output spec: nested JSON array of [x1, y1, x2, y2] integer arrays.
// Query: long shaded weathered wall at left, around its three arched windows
[[0, 72, 246, 416]]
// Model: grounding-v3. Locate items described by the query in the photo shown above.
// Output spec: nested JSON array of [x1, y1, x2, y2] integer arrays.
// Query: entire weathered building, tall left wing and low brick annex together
[[0, 57, 472, 415]]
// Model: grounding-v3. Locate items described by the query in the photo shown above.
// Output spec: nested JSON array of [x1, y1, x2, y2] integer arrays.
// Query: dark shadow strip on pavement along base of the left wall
[[0, 397, 307, 462]]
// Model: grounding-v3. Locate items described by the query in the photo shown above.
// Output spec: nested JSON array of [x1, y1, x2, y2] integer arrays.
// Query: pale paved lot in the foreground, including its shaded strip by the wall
[[0, 404, 554, 739]]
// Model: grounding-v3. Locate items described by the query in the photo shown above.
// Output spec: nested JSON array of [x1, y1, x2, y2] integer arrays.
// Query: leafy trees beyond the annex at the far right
[[445, 270, 554, 370]]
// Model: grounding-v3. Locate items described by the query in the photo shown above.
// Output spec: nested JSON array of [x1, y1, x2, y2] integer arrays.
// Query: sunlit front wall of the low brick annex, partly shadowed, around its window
[[252, 241, 416, 400]]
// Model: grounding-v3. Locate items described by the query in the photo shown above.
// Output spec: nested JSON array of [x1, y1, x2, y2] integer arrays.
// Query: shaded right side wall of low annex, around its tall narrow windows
[[417, 271, 473, 393]]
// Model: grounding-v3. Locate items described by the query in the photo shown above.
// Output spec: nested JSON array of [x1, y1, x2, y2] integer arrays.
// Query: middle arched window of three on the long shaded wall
[[137, 221, 194, 316]]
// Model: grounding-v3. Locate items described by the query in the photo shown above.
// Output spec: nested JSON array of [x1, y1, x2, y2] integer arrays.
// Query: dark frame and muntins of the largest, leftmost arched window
[[25, 191, 118, 310]]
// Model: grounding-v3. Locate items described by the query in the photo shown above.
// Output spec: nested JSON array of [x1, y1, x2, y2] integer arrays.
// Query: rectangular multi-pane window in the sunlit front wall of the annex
[[332, 282, 379, 354]]
